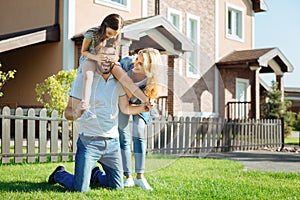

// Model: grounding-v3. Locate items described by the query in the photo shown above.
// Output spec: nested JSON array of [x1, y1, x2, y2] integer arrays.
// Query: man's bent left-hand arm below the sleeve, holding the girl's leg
[[64, 97, 87, 120]]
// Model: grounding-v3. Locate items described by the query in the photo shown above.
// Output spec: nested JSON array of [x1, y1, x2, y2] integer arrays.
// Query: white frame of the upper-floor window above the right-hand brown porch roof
[[225, 3, 245, 42]]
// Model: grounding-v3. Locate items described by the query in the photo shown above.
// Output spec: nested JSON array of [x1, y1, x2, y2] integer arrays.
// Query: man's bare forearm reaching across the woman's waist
[[119, 95, 149, 115]]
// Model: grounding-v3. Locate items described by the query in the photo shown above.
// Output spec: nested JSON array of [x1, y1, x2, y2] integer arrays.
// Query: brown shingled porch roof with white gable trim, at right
[[216, 47, 294, 74]]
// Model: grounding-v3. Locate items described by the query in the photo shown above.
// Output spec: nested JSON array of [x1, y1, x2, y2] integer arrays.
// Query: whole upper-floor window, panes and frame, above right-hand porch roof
[[226, 4, 244, 40]]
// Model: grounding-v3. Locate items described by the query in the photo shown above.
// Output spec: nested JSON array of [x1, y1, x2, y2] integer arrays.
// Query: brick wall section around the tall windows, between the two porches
[[148, 0, 215, 115]]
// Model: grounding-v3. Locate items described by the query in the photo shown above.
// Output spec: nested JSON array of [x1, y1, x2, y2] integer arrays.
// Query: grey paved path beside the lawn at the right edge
[[206, 150, 300, 173]]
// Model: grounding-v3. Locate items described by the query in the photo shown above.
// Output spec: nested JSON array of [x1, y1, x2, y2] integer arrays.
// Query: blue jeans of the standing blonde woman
[[118, 112, 146, 176]]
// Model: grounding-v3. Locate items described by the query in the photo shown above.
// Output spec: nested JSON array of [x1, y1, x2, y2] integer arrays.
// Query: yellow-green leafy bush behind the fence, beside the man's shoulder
[[35, 70, 76, 116]]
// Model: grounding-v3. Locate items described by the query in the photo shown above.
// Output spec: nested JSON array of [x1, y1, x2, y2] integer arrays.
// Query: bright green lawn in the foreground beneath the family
[[0, 156, 300, 200]]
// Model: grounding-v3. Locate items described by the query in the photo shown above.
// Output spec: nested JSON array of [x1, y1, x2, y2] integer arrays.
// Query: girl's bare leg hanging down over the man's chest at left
[[82, 60, 96, 105]]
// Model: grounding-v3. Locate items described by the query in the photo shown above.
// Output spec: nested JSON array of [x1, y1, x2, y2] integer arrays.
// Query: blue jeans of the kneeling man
[[54, 136, 123, 192]]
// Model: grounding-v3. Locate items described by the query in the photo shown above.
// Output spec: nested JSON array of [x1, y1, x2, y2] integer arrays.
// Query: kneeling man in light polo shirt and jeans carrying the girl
[[48, 48, 149, 192]]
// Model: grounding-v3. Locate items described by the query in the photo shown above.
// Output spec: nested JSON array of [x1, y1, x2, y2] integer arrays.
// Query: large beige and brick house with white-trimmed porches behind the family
[[0, 0, 293, 118]]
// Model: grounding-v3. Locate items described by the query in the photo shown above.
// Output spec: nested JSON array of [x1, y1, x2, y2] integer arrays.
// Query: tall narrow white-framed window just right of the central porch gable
[[186, 14, 200, 78]]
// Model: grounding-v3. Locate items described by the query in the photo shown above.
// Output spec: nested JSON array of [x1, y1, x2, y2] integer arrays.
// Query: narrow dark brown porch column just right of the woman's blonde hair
[[167, 55, 175, 116]]
